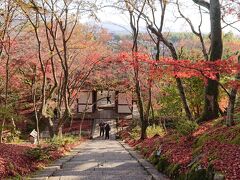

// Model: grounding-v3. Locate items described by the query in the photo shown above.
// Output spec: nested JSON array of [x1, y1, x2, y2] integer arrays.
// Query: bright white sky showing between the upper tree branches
[[84, 0, 240, 35]]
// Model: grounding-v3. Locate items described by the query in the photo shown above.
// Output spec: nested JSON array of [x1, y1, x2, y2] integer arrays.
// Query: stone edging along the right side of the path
[[118, 140, 169, 180]]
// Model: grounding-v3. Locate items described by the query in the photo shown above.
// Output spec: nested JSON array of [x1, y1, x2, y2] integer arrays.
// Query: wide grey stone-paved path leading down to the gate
[[31, 121, 165, 180]]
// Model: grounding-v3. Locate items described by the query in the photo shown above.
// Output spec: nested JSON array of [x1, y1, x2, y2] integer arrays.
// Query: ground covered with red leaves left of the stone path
[[0, 137, 85, 179]]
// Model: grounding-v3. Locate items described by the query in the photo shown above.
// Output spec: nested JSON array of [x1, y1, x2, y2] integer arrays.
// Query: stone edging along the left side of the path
[[26, 141, 86, 180]]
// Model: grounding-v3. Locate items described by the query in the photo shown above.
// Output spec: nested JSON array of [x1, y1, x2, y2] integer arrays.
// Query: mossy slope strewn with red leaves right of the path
[[120, 119, 240, 180]]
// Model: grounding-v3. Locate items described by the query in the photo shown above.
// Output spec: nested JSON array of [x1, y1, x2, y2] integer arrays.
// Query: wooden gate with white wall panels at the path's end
[[73, 90, 133, 119]]
